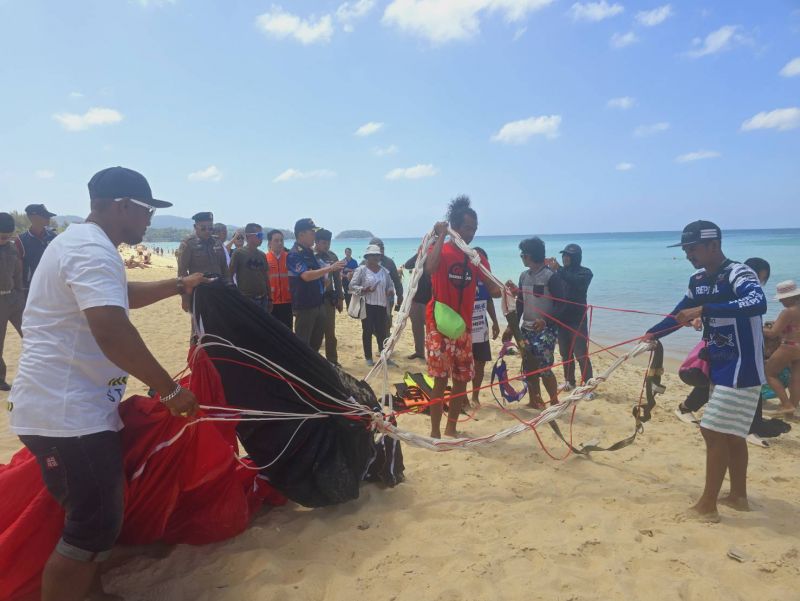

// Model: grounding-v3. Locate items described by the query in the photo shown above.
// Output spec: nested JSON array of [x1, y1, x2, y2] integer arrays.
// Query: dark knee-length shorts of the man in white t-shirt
[[19, 431, 125, 561]]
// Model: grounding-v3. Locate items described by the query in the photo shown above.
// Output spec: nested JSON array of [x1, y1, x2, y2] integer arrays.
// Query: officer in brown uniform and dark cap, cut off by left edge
[[0, 213, 25, 391]]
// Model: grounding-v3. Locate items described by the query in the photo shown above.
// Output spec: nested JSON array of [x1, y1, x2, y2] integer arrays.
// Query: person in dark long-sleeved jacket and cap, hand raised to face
[[547, 244, 594, 391]]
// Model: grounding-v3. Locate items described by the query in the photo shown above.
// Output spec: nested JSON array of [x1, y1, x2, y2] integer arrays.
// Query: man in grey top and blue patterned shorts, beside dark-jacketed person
[[503, 237, 565, 409]]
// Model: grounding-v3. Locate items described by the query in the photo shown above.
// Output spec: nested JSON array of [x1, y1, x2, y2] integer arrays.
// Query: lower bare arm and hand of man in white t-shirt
[[83, 305, 197, 415]]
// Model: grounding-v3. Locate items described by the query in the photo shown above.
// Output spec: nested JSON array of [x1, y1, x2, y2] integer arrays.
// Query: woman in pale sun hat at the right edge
[[764, 280, 800, 416]]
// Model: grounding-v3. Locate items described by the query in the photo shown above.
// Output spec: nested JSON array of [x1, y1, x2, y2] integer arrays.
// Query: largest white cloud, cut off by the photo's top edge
[[383, 0, 554, 44]]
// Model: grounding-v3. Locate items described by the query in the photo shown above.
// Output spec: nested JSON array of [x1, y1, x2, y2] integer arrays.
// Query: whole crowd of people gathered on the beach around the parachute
[[0, 167, 800, 599]]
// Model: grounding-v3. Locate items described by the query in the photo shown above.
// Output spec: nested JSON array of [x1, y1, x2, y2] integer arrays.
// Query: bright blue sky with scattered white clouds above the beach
[[0, 0, 800, 236]]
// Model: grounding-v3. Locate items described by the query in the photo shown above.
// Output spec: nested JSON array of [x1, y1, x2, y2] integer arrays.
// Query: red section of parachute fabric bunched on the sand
[[0, 354, 286, 601]]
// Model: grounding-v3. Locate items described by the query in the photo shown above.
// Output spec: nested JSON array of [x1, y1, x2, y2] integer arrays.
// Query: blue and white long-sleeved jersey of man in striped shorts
[[648, 259, 767, 388]]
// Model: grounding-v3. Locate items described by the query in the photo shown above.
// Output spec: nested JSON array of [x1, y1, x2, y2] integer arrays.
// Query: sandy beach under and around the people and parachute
[[0, 257, 800, 601]]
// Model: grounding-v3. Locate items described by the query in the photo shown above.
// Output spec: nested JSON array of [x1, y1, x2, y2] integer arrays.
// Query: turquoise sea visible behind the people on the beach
[[147, 228, 800, 357]]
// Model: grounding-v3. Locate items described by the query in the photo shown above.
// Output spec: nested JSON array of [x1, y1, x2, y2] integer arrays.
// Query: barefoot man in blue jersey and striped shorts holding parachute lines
[[646, 221, 767, 522]]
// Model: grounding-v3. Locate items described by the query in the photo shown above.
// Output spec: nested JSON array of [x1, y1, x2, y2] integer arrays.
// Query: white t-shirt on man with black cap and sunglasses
[[9, 223, 128, 437]]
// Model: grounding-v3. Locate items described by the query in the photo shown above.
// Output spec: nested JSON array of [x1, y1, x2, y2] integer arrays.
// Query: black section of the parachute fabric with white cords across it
[[193, 282, 404, 507]]
